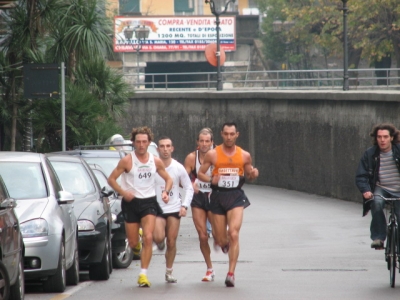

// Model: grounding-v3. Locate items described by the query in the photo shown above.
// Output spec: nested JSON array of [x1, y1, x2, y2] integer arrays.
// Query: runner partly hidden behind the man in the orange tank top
[[184, 128, 215, 282]]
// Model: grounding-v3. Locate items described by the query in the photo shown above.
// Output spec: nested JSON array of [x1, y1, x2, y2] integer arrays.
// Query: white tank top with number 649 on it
[[121, 151, 157, 199]]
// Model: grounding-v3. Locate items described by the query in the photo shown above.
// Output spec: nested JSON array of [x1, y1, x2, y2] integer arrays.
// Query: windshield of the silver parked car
[[0, 161, 47, 200]]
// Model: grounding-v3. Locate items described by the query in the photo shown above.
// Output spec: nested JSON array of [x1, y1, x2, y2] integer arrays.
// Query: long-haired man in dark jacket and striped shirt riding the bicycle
[[356, 124, 400, 249]]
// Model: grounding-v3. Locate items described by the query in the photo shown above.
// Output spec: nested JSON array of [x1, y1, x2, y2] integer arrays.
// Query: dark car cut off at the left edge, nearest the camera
[[0, 176, 25, 300]]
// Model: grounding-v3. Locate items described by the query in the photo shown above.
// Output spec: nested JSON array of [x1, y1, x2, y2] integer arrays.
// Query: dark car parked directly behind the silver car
[[47, 154, 112, 280]]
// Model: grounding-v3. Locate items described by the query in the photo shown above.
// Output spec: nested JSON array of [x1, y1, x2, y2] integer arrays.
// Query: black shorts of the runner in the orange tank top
[[210, 189, 250, 215]]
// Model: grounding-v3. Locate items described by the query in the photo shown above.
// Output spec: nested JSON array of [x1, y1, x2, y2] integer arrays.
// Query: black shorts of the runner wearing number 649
[[121, 196, 163, 223]]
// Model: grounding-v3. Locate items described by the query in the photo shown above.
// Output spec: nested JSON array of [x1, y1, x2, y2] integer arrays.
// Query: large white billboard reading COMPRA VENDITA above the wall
[[114, 16, 236, 52]]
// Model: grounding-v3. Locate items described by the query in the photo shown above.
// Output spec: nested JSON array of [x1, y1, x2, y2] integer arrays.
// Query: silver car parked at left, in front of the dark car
[[0, 151, 79, 292]]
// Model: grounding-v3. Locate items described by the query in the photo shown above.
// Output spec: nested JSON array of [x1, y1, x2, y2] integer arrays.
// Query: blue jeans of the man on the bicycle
[[371, 186, 400, 241]]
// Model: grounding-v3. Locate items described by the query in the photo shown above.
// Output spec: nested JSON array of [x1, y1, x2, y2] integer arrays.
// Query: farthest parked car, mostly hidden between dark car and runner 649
[[89, 164, 134, 269]]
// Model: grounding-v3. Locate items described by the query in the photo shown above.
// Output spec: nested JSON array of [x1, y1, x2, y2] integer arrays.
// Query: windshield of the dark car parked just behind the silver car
[[51, 161, 95, 196]]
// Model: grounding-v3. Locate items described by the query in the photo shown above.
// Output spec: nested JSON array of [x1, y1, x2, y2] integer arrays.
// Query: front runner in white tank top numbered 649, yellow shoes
[[108, 127, 172, 287]]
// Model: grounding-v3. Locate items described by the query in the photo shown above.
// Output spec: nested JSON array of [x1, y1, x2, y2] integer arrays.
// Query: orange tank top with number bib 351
[[212, 146, 244, 189]]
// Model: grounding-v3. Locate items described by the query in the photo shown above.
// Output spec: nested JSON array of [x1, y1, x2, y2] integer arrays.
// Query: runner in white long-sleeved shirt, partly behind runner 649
[[153, 137, 193, 283]]
